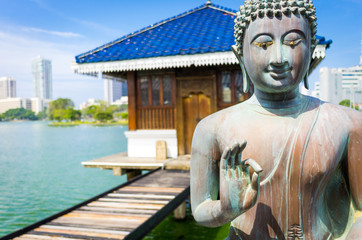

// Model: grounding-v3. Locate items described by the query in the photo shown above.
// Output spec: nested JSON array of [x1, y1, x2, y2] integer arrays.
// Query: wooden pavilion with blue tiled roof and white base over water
[[72, 1, 332, 158]]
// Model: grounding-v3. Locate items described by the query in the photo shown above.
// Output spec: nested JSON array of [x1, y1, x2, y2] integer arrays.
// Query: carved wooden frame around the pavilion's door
[[176, 75, 217, 155]]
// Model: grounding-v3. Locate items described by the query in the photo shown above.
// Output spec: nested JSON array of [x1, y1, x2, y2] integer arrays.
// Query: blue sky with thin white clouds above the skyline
[[0, 0, 362, 107]]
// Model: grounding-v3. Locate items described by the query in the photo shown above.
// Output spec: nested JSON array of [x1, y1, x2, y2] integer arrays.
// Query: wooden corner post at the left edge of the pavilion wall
[[127, 72, 137, 131]]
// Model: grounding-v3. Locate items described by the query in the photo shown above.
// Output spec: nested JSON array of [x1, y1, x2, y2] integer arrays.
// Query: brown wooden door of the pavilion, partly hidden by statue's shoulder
[[182, 93, 211, 154]]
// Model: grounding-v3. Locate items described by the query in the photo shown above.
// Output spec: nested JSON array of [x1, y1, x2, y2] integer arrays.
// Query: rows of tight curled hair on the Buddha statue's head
[[234, 0, 317, 56]]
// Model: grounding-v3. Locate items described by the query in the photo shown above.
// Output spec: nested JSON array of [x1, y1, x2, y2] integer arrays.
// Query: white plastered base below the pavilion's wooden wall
[[124, 130, 177, 158]]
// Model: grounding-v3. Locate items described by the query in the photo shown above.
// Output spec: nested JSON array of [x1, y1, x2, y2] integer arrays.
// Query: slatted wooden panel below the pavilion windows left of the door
[[137, 107, 176, 129]]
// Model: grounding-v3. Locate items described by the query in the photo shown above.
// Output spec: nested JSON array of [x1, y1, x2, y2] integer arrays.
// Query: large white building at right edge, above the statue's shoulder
[[312, 66, 362, 104]]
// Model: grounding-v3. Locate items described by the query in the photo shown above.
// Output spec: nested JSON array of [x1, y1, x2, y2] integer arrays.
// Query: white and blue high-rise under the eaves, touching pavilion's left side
[[104, 79, 127, 104]]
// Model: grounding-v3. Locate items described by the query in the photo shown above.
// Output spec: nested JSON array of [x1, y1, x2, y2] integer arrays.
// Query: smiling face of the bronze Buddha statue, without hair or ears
[[243, 14, 311, 93]]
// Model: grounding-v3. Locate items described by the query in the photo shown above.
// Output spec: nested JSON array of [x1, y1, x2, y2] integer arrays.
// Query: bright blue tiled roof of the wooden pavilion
[[75, 4, 330, 63]]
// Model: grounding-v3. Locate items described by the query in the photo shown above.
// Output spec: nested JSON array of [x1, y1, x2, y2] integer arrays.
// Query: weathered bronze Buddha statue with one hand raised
[[191, 0, 362, 240]]
